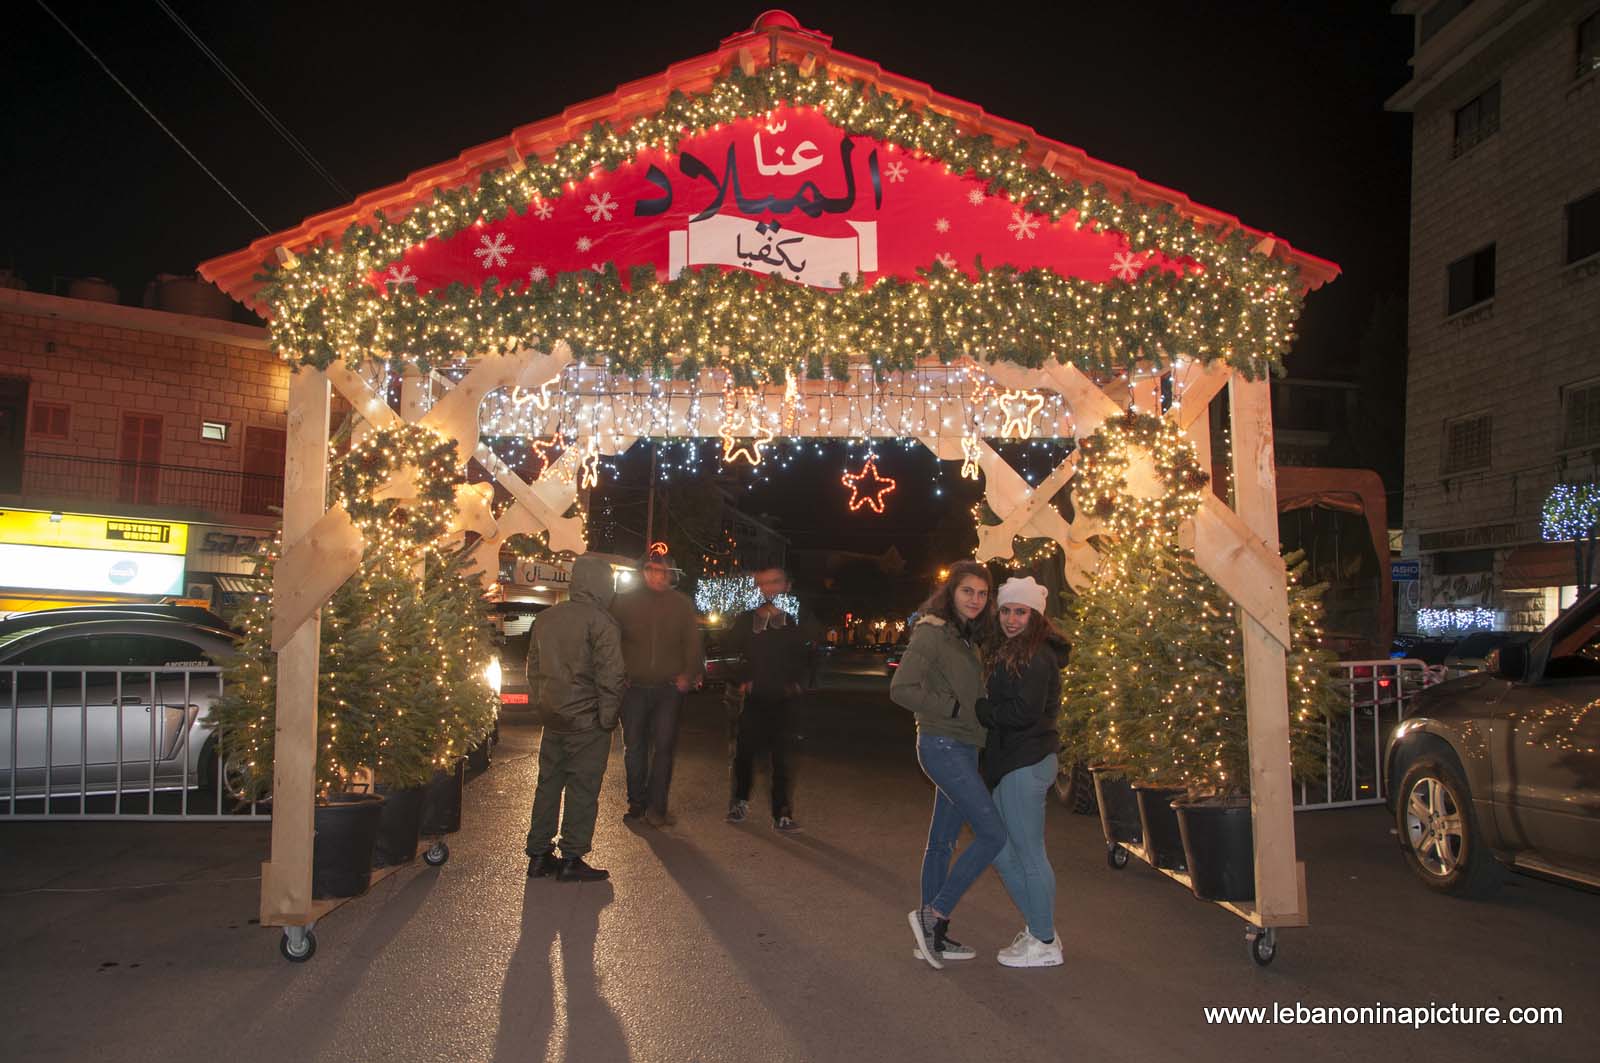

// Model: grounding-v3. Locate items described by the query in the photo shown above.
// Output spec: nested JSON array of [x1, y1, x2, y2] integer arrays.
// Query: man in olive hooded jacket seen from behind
[[526, 554, 624, 882]]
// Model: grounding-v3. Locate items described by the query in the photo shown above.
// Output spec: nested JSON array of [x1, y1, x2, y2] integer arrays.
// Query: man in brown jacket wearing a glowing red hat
[[611, 554, 706, 826]]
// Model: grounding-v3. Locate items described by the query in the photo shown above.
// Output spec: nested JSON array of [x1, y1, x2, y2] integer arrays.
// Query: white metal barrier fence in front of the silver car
[[0, 664, 269, 820]]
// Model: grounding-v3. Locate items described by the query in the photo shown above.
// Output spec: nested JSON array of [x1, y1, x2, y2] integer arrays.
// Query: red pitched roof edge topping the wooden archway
[[200, 11, 1339, 314]]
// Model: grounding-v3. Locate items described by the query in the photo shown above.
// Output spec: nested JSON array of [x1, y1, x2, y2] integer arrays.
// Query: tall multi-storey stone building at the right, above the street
[[1387, 0, 1600, 631]]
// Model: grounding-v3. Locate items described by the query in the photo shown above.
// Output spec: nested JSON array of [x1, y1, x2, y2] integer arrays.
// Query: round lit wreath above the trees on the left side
[[334, 424, 459, 548]]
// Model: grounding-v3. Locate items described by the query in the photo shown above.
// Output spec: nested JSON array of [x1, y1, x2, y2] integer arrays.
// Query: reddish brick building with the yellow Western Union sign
[[0, 288, 290, 613]]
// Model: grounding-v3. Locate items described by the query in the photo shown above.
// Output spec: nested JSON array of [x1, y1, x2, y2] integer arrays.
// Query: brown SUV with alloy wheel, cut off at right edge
[[1384, 589, 1600, 895]]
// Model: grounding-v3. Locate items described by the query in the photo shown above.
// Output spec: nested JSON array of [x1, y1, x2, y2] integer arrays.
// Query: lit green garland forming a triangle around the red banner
[[259, 62, 1302, 381]]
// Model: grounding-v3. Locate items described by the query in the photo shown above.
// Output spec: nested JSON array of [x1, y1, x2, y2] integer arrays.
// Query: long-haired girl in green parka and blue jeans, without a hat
[[890, 560, 1006, 969]]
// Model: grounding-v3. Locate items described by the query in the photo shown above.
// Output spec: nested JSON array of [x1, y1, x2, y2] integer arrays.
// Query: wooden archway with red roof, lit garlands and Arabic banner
[[202, 13, 1338, 947]]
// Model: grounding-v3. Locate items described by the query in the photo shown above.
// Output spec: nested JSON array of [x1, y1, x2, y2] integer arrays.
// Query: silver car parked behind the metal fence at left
[[0, 605, 235, 799]]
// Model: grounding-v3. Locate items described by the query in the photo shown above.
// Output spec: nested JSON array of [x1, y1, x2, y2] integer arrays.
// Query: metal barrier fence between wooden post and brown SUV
[[1294, 658, 1445, 810]]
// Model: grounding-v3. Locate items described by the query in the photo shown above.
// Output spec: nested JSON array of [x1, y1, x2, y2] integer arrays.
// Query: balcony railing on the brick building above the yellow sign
[[22, 450, 283, 515]]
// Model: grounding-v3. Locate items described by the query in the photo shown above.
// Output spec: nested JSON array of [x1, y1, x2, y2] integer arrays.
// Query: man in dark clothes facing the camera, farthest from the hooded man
[[726, 565, 813, 832]]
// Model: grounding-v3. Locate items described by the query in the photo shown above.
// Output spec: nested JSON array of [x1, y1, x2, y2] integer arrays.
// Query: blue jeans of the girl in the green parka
[[917, 735, 1006, 919]]
